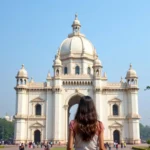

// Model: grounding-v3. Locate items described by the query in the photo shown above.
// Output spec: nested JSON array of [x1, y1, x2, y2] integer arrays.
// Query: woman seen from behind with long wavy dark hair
[[67, 96, 105, 150]]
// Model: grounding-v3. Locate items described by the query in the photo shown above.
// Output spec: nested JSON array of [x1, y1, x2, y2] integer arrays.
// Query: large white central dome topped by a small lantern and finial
[[60, 15, 96, 58]]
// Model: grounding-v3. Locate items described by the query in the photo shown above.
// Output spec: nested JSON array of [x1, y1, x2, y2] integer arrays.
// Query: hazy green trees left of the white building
[[0, 118, 14, 140]]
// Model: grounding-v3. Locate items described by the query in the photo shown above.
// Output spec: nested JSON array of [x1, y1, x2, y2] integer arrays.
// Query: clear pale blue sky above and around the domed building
[[0, 0, 150, 125]]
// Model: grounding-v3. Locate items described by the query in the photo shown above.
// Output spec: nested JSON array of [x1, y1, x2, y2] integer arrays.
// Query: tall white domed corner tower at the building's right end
[[126, 64, 140, 144]]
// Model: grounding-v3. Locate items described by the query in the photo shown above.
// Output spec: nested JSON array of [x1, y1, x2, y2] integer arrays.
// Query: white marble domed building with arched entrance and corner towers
[[15, 15, 140, 143]]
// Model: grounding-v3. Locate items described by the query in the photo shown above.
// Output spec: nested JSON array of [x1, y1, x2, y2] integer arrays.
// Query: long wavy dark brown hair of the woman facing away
[[75, 96, 98, 142]]
